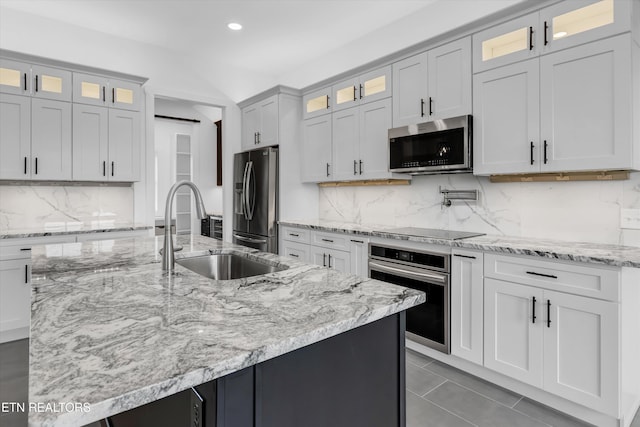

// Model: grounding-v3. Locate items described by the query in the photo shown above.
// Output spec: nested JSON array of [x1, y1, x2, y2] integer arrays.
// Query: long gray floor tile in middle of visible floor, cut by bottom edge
[[424, 381, 548, 427]]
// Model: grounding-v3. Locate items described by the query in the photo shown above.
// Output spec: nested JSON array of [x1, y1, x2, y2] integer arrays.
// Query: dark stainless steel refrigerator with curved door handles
[[233, 147, 278, 254]]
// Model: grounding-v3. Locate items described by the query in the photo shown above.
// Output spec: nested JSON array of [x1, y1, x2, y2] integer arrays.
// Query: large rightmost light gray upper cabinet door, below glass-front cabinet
[[540, 34, 633, 172]]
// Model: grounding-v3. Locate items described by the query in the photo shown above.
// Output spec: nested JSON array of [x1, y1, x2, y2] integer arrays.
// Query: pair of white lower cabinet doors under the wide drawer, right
[[484, 270, 620, 416]]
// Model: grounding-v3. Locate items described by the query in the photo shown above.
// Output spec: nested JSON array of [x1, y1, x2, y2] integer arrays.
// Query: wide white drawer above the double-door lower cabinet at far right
[[484, 253, 620, 301]]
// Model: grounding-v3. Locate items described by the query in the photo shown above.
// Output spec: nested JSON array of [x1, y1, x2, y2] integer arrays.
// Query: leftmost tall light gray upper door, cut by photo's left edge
[[0, 93, 31, 179]]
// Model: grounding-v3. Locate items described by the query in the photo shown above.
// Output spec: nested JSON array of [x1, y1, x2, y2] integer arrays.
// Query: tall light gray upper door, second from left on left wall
[[31, 98, 71, 181]]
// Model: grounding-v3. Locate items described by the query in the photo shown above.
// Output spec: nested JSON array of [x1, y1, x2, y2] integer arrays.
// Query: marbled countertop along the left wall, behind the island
[[0, 220, 153, 239]]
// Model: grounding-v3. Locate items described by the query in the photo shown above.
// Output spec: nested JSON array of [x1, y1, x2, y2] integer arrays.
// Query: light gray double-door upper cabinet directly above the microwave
[[393, 37, 471, 127]]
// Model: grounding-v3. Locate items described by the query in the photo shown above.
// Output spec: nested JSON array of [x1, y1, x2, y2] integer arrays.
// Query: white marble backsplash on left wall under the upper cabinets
[[0, 185, 134, 233]]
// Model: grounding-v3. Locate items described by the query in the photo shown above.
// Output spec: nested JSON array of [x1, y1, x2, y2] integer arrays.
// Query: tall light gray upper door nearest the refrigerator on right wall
[[302, 114, 331, 182]]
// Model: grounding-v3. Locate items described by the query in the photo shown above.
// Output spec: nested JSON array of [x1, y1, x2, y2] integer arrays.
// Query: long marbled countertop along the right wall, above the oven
[[279, 220, 640, 268]]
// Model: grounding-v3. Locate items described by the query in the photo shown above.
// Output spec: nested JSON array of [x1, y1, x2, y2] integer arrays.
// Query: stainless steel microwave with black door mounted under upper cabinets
[[389, 116, 473, 175]]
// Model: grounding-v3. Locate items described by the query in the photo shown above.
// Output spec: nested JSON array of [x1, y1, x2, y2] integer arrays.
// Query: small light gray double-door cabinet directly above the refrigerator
[[242, 95, 279, 150]]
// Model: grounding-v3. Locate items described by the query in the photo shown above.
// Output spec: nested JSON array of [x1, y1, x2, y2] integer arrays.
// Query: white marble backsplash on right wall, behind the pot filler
[[319, 173, 640, 246]]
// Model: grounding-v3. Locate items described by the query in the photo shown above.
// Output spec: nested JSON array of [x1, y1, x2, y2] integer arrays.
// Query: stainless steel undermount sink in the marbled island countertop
[[176, 253, 287, 280]]
